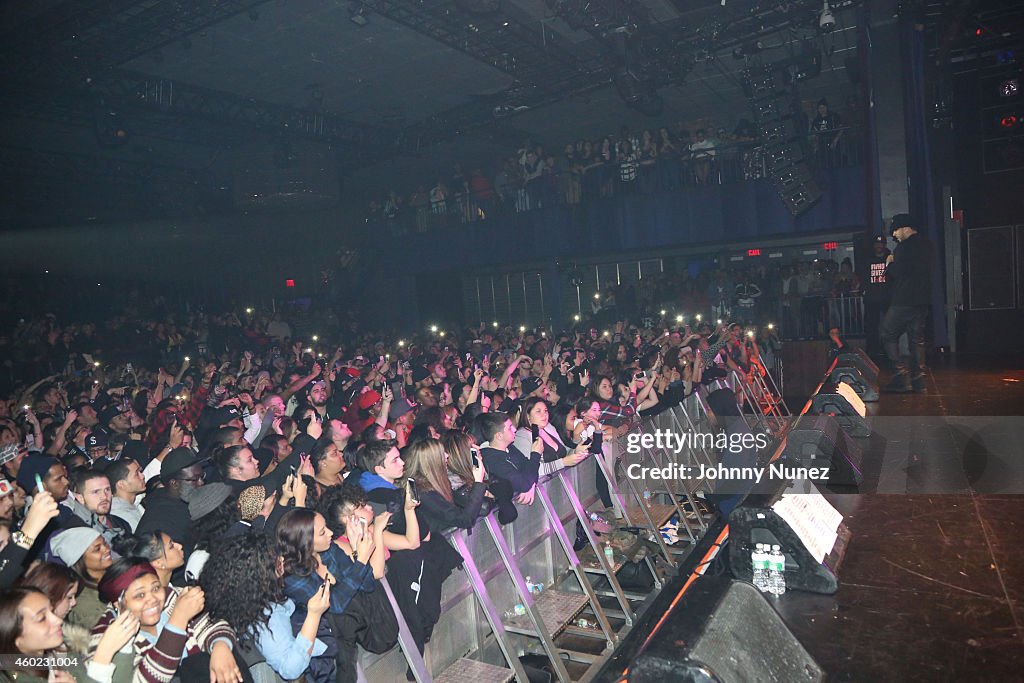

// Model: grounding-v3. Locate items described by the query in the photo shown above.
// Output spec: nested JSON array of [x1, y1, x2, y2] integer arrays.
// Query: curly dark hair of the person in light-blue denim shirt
[[200, 533, 285, 641]]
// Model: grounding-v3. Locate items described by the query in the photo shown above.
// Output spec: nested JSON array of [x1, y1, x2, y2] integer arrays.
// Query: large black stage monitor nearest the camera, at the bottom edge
[[630, 574, 825, 683]]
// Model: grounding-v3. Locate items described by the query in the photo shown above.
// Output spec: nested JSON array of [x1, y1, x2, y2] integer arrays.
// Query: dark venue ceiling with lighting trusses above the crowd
[[0, 0, 872, 228]]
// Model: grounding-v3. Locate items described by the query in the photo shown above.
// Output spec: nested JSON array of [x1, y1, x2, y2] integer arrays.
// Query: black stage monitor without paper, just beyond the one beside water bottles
[[782, 415, 864, 486]]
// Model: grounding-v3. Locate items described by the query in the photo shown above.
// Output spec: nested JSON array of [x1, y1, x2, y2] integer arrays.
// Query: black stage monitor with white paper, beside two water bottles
[[729, 479, 850, 595]]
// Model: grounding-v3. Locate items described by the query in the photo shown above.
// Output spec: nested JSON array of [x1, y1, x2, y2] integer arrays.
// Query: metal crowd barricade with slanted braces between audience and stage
[[360, 389, 770, 683]]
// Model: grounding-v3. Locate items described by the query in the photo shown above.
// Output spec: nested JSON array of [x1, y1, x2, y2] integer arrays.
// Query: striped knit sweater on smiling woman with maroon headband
[[89, 586, 236, 683]]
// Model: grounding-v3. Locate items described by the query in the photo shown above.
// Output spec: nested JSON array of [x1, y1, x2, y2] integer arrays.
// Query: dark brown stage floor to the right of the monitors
[[773, 357, 1024, 681]]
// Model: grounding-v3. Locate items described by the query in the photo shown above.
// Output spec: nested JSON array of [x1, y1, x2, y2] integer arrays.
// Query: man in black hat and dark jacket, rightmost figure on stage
[[880, 213, 932, 392]]
